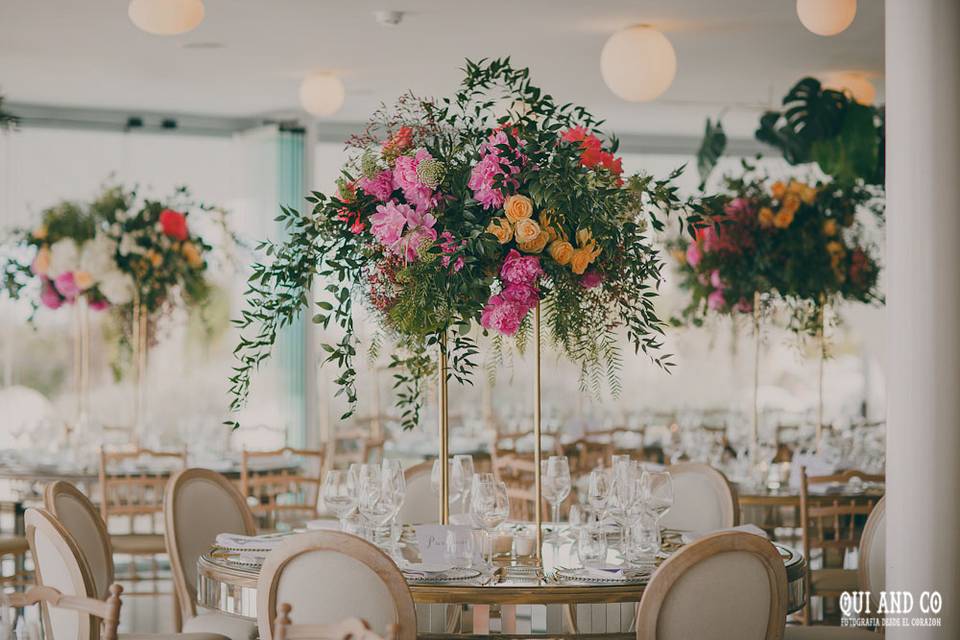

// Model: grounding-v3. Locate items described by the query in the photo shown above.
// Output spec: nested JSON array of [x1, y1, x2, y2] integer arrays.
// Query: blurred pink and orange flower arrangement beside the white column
[[671, 172, 883, 334]]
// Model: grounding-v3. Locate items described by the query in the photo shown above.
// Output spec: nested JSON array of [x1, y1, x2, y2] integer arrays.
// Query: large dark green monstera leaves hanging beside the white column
[[755, 78, 883, 183]]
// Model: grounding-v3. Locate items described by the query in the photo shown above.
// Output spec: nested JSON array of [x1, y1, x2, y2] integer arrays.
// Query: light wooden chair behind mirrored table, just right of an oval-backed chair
[[240, 447, 326, 528]]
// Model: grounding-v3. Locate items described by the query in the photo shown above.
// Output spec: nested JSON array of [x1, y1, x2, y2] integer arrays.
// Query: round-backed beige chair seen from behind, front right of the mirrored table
[[636, 531, 787, 640]]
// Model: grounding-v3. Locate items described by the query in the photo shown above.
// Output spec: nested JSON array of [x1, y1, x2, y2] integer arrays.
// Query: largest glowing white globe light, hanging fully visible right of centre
[[600, 25, 677, 102]]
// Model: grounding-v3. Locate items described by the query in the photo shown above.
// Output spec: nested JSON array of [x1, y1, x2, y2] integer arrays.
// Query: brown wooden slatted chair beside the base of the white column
[[800, 467, 884, 624]]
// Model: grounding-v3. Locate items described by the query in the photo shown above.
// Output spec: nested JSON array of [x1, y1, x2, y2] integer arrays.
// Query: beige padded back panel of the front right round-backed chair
[[657, 551, 771, 640]]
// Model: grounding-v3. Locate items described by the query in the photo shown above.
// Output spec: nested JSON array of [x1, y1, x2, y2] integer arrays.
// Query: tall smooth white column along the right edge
[[886, 0, 960, 640]]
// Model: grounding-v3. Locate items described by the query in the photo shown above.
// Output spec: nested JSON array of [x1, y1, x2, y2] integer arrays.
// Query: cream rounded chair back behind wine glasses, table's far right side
[[661, 462, 740, 532]]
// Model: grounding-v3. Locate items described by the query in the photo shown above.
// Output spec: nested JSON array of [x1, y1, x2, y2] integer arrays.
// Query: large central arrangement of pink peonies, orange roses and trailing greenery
[[231, 59, 702, 427]]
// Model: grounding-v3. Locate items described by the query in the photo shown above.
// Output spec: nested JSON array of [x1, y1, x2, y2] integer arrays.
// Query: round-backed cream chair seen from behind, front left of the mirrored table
[[257, 531, 417, 640]]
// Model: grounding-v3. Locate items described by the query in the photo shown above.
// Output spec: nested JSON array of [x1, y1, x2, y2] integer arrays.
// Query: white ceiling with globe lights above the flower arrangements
[[0, 0, 883, 135]]
